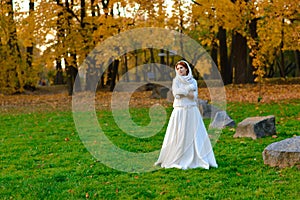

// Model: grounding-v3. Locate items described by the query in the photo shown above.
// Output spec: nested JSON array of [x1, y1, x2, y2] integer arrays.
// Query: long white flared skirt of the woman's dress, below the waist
[[155, 106, 218, 169]]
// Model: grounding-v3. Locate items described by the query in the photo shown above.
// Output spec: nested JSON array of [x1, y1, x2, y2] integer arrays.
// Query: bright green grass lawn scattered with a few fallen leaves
[[0, 100, 300, 199]]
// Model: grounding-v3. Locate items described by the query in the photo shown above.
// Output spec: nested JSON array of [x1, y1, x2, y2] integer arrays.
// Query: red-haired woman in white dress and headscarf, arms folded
[[155, 61, 218, 169]]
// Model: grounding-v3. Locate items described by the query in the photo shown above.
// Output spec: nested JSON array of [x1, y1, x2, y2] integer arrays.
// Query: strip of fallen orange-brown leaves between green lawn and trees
[[0, 84, 300, 113]]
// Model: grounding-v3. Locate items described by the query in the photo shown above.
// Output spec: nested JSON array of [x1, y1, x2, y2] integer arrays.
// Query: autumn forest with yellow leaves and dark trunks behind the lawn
[[0, 0, 300, 95]]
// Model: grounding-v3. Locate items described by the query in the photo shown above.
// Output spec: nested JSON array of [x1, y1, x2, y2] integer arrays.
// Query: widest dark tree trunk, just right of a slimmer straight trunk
[[230, 31, 248, 84]]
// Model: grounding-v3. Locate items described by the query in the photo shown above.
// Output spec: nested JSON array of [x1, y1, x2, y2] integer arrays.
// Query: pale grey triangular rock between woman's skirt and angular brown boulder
[[209, 111, 235, 129]]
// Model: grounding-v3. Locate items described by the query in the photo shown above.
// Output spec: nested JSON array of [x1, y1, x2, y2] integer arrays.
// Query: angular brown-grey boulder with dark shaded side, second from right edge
[[233, 115, 276, 139]]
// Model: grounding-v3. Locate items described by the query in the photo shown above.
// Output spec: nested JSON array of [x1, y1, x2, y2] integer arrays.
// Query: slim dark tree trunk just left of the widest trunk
[[218, 26, 232, 85]]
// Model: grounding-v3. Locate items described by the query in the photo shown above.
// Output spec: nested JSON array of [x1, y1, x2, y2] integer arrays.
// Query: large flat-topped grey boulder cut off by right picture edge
[[262, 136, 300, 168]]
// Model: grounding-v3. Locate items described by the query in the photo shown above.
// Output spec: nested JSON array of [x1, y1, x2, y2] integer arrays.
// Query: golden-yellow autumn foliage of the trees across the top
[[0, 0, 300, 91]]
